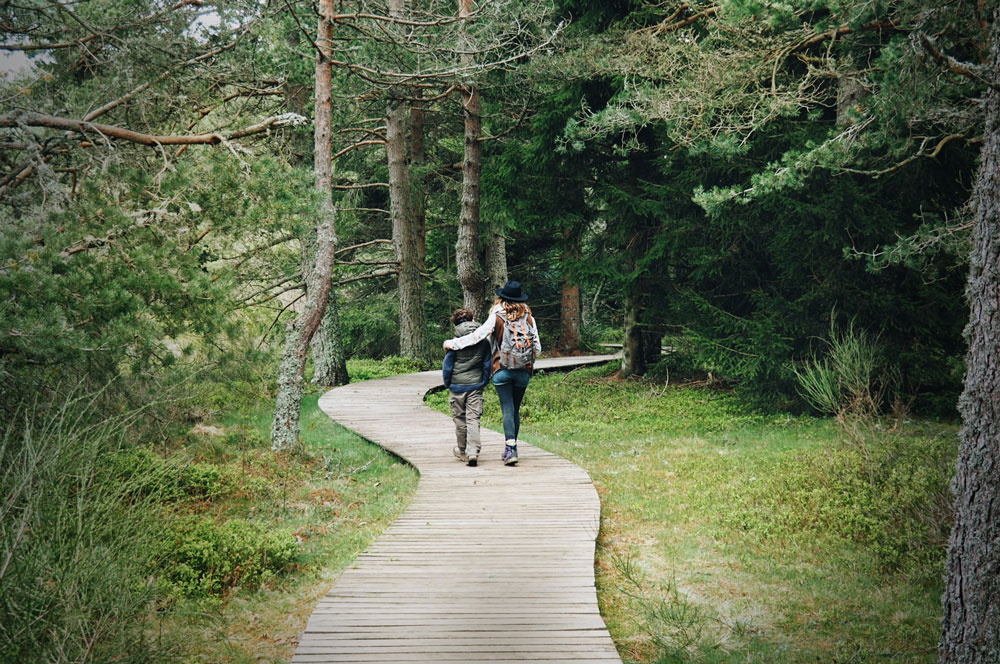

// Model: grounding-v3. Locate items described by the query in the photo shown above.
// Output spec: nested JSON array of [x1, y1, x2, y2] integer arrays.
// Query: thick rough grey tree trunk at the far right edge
[[938, 9, 1000, 664]]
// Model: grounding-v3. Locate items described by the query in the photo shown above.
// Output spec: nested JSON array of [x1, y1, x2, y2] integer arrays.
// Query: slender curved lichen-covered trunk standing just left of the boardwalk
[[271, 0, 336, 450]]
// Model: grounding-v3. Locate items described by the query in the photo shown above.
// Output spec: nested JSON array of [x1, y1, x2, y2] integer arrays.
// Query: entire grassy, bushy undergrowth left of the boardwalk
[[0, 360, 416, 663]]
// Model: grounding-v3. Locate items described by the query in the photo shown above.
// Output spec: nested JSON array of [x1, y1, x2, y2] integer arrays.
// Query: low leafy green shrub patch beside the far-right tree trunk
[[721, 434, 956, 579]]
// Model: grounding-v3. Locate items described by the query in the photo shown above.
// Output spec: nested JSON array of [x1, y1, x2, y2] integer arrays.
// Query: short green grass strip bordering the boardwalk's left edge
[[160, 376, 417, 664]]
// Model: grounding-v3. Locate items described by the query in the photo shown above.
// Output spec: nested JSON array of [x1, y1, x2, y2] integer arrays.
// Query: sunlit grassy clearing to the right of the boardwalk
[[429, 367, 956, 663]]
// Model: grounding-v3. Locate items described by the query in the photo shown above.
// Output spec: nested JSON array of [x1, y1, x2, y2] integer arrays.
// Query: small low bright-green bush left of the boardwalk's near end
[[158, 517, 298, 597]]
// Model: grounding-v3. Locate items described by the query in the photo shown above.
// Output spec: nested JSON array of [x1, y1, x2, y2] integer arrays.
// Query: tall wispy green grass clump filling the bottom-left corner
[[0, 399, 167, 662]]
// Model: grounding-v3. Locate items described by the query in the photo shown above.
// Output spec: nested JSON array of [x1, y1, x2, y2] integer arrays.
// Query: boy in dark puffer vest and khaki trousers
[[442, 309, 493, 466]]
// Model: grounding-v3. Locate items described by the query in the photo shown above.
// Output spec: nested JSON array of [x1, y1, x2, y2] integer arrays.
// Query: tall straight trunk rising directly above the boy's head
[[455, 0, 486, 320]]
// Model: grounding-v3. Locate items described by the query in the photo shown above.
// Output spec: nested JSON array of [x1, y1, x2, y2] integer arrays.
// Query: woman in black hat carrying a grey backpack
[[444, 281, 542, 466]]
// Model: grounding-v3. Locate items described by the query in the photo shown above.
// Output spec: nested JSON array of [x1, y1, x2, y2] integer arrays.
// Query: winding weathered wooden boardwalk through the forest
[[292, 356, 621, 664]]
